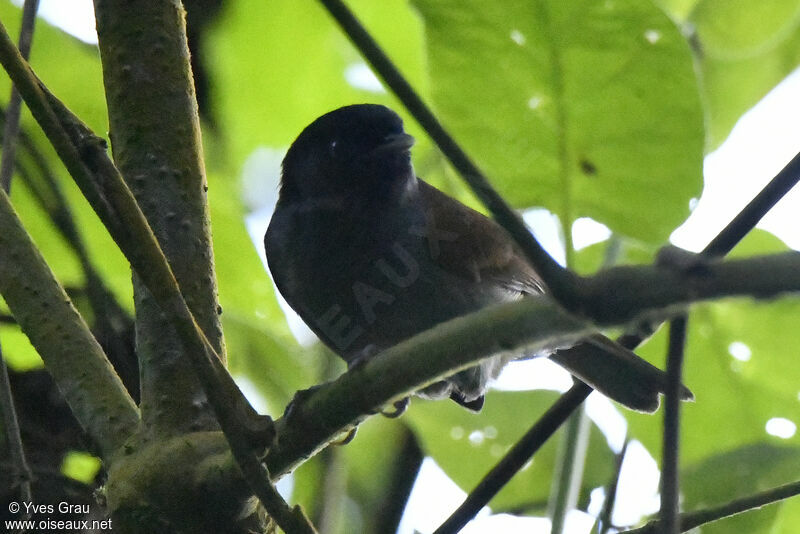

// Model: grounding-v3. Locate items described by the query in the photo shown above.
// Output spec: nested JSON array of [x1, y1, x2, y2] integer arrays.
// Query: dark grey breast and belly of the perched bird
[[267, 202, 500, 360]]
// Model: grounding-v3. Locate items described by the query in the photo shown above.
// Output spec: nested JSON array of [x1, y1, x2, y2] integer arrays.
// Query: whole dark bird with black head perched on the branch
[[264, 104, 691, 412]]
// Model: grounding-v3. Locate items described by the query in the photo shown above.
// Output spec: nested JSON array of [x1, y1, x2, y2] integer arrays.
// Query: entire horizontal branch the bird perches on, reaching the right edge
[[266, 252, 800, 476]]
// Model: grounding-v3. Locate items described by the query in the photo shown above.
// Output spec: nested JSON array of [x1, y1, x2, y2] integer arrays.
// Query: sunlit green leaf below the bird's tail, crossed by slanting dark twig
[[405, 391, 614, 514]]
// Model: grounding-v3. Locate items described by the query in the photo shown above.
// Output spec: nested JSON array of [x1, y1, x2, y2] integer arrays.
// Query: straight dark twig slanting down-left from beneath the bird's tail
[[434, 382, 592, 534]]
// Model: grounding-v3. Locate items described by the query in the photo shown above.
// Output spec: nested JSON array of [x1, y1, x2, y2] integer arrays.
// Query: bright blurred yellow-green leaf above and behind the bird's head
[[208, 0, 424, 169]]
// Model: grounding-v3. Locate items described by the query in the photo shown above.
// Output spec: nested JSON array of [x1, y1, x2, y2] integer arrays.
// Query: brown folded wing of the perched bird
[[419, 180, 545, 294]]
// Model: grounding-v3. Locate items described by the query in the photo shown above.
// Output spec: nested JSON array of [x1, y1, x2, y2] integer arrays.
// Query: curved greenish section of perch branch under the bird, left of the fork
[[266, 298, 591, 476]]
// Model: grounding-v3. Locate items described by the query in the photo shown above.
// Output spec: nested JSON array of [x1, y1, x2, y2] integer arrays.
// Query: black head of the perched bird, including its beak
[[281, 104, 415, 200]]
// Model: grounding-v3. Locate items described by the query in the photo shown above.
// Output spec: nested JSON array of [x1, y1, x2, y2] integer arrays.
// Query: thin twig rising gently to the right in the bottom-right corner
[[625, 481, 800, 534]]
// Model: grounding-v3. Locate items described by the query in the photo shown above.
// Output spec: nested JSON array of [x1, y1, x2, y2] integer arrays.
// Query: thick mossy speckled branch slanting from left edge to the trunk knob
[[0, 186, 139, 459]]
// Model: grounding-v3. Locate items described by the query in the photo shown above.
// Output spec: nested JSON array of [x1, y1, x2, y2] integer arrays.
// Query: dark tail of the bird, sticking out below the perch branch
[[550, 334, 694, 413]]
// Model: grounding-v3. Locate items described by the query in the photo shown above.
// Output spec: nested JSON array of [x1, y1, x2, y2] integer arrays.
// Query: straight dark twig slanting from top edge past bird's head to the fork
[[320, 0, 580, 309]]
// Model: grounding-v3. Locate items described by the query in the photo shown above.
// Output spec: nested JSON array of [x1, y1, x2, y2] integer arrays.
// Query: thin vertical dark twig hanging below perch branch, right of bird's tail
[[661, 315, 688, 534]]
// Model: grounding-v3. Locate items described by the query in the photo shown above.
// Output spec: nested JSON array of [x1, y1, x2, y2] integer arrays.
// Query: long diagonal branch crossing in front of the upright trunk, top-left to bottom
[[0, 13, 313, 532]]
